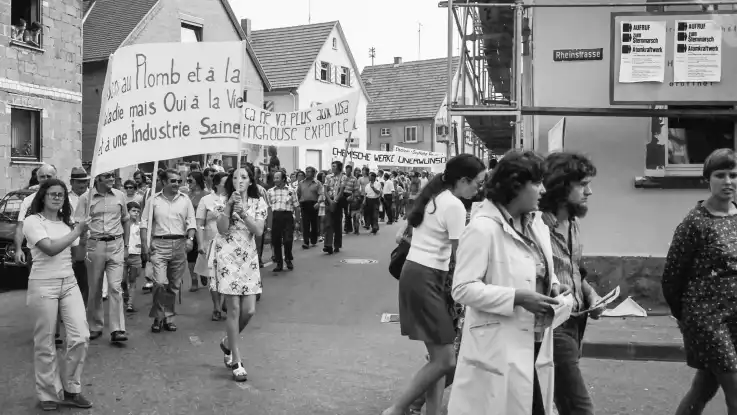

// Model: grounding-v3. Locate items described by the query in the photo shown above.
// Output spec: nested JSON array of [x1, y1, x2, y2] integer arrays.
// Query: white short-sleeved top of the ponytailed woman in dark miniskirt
[[407, 190, 466, 271]]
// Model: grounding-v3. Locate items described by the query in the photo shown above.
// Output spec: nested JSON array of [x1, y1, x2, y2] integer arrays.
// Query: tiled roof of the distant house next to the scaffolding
[[361, 57, 460, 122]]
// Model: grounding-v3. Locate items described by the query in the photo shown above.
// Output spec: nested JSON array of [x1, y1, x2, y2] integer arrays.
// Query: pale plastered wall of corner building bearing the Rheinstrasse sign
[[525, 0, 708, 257]]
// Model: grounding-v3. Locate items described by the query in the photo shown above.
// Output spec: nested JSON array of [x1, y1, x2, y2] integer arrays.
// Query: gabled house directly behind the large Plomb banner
[[82, 0, 271, 177]]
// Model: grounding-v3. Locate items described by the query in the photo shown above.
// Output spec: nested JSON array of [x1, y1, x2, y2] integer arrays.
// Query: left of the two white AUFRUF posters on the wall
[[619, 20, 666, 83]]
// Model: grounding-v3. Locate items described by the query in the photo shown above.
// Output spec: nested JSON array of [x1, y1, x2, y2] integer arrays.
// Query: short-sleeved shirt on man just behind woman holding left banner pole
[[74, 187, 129, 238]]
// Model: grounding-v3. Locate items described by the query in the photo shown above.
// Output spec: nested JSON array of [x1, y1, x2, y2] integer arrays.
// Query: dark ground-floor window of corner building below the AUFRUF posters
[[646, 106, 735, 177]]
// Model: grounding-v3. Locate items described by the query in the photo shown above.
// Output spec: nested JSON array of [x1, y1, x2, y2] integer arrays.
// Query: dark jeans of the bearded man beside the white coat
[[553, 316, 594, 415]]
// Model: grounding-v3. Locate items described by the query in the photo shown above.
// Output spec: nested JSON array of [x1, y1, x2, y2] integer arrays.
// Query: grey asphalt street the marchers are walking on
[[0, 219, 726, 415]]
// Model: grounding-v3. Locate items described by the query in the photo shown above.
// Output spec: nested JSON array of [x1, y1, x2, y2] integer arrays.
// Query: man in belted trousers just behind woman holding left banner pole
[[74, 172, 130, 343]]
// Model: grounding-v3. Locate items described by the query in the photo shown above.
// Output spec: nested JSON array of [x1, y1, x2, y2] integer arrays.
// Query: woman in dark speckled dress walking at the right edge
[[662, 148, 737, 415]]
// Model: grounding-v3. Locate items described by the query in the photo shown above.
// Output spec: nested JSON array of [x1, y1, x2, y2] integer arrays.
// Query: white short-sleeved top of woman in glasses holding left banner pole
[[23, 214, 79, 280]]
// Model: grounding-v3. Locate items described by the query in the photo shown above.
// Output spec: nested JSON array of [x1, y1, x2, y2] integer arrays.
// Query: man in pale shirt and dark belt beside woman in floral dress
[[140, 169, 196, 333]]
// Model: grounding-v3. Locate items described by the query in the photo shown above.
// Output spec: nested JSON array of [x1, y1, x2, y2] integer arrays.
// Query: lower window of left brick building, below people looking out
[[10, 108, 41, 161]]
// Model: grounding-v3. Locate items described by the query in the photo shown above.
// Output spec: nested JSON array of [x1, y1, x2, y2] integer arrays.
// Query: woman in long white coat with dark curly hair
[[448, 151, 568, 415]]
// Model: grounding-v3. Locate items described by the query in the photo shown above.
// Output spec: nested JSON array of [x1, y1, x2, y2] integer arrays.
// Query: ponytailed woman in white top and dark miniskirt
[[383, 154, 486, 415]]
